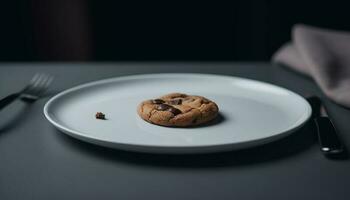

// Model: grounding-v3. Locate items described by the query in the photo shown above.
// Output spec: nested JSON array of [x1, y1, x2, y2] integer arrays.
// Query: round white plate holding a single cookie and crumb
[[44, 74, 311, 153]]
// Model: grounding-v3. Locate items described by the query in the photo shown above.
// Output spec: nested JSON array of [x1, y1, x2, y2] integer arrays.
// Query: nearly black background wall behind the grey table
[[0, 0, 350, 61]]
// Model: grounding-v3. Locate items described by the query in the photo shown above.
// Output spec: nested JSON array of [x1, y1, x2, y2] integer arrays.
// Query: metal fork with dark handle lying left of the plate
[[0, 73, 53, 110]]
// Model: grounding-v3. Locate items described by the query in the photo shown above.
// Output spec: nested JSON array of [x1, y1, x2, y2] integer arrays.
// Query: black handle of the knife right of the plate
[[315, 117, 344, 156]]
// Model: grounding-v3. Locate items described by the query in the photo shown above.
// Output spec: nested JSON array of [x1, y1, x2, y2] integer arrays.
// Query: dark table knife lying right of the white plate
[[307, 96, 344, 157]]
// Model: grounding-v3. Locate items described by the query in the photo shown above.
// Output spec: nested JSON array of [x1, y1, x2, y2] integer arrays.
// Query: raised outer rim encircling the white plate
[[43, 73, 312, 153]]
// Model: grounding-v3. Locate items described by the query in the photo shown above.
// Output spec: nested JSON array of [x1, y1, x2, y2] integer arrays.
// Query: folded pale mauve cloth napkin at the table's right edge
[[272, 24, 350, 107]]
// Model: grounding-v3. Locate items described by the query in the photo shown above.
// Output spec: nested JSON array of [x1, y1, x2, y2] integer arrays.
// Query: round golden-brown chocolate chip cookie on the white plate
[[137, 93, 219, 127]]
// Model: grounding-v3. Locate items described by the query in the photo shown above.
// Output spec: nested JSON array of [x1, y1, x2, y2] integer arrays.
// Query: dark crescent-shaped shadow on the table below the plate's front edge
[[55, 118, 324, 168]]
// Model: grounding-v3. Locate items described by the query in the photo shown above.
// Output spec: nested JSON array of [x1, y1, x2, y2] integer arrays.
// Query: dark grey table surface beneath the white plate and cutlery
[[0, 62, 350, 200]]
